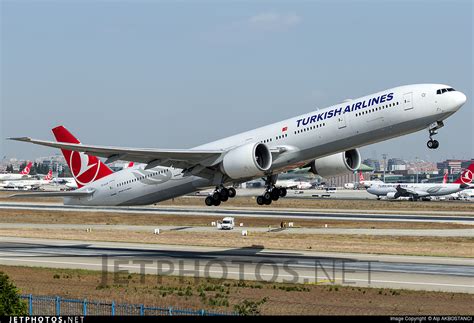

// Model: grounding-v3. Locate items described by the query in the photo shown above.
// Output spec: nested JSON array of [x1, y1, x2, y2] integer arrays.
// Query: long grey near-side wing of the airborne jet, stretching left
[[8, 137, 225, 168]]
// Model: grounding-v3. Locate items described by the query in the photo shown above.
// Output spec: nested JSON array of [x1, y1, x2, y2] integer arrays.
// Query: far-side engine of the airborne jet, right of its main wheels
[[310, 149, 361, 178]]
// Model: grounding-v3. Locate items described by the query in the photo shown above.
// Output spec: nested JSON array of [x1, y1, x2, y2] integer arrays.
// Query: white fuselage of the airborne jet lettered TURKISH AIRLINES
[[65, 84, 465, 206]]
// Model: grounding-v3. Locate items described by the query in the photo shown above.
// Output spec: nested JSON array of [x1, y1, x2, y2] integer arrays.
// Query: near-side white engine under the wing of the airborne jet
[[221, 143, 272, 179]]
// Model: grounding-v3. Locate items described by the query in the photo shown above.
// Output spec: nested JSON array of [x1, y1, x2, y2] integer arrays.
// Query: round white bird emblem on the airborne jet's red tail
[[69, 151, 100, 187]]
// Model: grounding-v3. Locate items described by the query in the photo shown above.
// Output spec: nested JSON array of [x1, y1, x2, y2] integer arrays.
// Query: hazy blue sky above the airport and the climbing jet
[[0, 0, 474, 160]]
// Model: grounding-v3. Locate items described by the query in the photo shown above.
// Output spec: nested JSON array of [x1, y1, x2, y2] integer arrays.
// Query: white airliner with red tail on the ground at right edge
[[367, 163, 474, 201]]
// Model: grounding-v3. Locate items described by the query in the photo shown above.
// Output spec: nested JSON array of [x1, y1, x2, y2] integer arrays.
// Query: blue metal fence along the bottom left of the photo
[[21, 294, 238, 316]]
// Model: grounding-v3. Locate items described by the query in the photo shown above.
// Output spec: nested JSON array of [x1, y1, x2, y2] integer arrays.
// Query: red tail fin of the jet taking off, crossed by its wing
[[52, 126, 113, 188]]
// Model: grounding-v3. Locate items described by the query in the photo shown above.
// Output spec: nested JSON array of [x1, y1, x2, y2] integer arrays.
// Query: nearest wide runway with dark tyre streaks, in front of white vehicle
[[0, 237, 474, 293]]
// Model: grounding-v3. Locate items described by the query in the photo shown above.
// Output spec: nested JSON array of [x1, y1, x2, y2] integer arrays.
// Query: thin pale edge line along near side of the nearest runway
[[0, 258, 474, 288]]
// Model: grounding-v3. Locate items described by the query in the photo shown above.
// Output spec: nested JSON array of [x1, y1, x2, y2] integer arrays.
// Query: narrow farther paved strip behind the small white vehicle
[[0, 202, 474, 224]]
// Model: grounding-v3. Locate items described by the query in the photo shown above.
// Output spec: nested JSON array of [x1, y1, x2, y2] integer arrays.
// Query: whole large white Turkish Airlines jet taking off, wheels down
[[10, 84, 466, 206]]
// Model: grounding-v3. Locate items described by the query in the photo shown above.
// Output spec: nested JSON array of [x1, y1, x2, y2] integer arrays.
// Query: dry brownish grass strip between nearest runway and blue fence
[[0, 266, 474, 315]]
